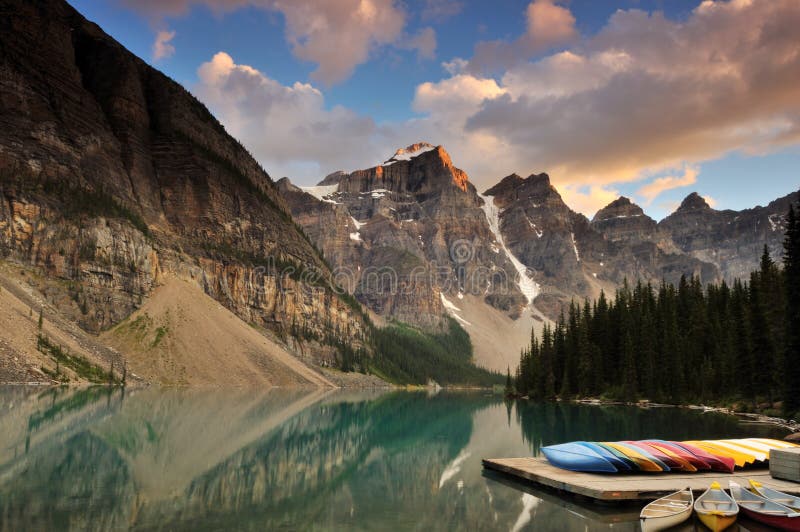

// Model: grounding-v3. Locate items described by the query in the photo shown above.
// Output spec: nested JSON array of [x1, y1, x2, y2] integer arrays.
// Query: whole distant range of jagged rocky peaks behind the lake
[[278, 142, 797, 369]]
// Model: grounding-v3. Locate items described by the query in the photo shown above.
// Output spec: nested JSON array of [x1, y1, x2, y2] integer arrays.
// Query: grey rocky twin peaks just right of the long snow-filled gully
[[485, 174, 719, 317]]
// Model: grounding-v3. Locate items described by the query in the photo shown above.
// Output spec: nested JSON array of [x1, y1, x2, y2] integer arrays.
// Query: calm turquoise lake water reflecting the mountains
[[0, 387, 781, 532]]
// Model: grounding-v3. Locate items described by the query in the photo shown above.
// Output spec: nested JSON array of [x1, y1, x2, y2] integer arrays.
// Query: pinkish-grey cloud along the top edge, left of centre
[[125, 0, 412, 85]]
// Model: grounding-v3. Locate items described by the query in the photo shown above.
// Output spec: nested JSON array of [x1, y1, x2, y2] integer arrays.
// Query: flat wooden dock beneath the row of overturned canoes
[[483, 458, 800, 501]]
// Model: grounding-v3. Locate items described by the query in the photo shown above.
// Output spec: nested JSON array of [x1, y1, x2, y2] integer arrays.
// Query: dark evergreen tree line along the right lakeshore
[[513, 197, 800, 416]]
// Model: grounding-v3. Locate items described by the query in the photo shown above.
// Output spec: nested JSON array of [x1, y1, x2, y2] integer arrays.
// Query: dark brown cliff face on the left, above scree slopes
[[0, 0, 364, 366]]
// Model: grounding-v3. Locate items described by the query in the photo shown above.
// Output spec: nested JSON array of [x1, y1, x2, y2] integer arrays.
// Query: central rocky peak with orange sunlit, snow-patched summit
[[279, 143, 527, 330]]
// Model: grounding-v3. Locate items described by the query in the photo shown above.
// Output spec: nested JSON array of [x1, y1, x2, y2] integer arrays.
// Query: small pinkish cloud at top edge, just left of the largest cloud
[[469, 0, 577, 73]]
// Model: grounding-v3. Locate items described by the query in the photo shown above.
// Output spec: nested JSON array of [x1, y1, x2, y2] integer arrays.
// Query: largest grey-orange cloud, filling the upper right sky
[[450, 0, 800, 196]]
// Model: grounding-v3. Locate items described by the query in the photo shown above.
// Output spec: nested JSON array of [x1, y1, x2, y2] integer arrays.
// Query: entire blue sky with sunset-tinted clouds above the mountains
[[70, 0, 800, 219]]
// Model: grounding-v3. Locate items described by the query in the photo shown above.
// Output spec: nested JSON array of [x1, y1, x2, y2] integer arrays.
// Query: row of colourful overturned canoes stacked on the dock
[[542, 438, 797, 473]]
